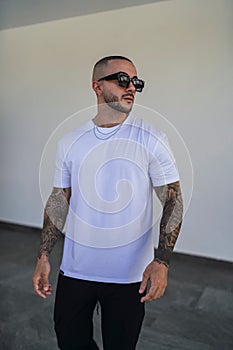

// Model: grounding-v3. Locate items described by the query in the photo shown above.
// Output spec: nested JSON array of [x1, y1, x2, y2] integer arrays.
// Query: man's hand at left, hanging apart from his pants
[[32, 257, 52, 299]]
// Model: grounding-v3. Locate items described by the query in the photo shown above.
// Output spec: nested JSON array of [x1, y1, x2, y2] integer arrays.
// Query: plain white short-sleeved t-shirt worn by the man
[[54, 115, 179, 283]]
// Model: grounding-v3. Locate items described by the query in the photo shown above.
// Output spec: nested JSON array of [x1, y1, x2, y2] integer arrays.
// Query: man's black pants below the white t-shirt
[[54, 274, 145, 350]]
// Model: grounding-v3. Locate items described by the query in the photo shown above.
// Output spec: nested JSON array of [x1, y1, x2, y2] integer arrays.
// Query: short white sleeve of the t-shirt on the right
[[149, 133, 179, 186]]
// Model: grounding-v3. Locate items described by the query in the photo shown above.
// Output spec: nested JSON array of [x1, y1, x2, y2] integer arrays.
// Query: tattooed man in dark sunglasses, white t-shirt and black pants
[[33, 56, 182, 350]]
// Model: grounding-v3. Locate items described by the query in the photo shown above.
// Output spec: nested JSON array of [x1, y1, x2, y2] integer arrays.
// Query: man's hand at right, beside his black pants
[[139, 261, 168, 303]]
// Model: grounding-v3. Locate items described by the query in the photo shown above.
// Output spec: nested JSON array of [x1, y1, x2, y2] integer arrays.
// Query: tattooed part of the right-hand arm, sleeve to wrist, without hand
[[155, 181, 183, 267]]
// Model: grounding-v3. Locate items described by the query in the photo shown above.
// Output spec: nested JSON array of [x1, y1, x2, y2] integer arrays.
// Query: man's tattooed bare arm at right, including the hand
[[139, 181, 183, 302]]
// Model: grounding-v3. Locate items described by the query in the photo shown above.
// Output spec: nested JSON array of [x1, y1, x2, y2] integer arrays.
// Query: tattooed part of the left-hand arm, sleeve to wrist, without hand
[[38, 188, 70, 259]]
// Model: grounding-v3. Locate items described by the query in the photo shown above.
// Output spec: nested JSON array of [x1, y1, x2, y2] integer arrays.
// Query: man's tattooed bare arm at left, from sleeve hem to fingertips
[[32, 188, 71, 298]]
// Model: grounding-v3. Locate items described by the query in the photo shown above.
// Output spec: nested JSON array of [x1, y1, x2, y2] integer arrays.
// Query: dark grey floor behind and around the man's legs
[[0, 223, 233, 350]]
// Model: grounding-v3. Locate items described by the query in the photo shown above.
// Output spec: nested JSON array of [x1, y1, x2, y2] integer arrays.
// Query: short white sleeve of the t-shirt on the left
[[53, 141, 71, 188]]
